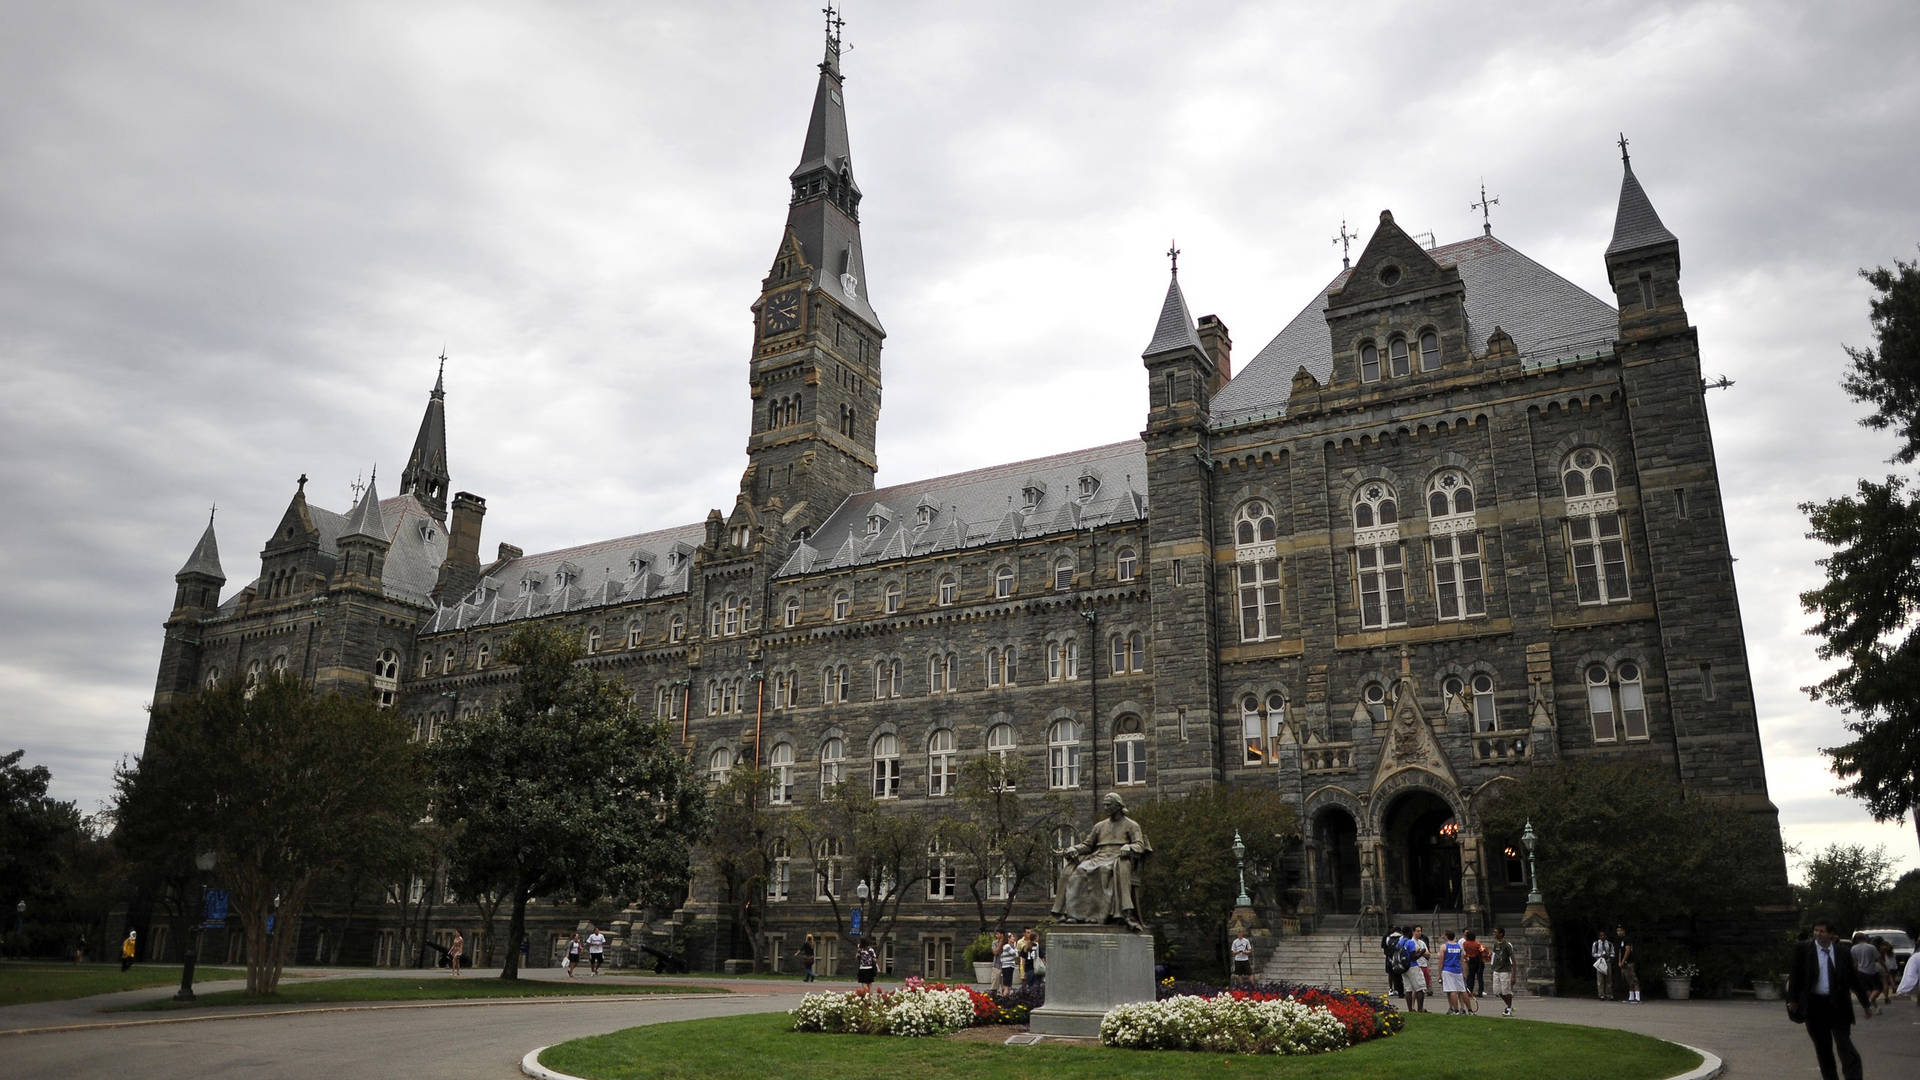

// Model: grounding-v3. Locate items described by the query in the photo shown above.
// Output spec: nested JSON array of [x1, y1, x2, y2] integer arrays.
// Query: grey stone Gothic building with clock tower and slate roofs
[[145, 29, 1784, 976]]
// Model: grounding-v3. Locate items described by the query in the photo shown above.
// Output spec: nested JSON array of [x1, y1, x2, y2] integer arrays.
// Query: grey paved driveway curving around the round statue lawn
[[0, 969, 1920, 1080]]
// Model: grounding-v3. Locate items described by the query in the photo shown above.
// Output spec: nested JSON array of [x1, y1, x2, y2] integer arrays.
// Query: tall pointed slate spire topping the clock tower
[[781, 6, 879, 329]]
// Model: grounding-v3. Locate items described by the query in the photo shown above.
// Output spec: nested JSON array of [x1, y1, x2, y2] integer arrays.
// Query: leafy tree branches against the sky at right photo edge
[[1801, 253, 1920, 849]]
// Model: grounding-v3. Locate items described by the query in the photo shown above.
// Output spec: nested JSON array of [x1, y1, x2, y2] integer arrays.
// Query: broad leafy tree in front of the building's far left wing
[[115, 676, 424, 995]]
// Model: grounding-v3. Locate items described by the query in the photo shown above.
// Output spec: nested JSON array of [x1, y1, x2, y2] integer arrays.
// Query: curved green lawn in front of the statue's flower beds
[[540, 1013, 1699, 1080]]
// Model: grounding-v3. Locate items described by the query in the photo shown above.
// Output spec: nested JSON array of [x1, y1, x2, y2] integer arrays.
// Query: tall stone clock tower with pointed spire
[[733, 13, 887, 550]]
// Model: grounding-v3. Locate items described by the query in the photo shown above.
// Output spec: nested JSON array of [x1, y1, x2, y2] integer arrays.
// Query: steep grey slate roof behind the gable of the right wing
[[1212, 234, 1620, 427]]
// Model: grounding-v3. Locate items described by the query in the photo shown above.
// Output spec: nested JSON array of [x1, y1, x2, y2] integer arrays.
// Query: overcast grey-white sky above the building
[[0, 0, 1920, 880]]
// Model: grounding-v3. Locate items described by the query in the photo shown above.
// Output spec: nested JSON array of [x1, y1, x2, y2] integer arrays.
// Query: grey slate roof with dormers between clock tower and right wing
[[774, 440, 1146, 577]]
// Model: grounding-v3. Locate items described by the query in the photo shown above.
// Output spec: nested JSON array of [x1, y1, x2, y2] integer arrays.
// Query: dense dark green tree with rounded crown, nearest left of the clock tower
[[428, 626, 710, 978]]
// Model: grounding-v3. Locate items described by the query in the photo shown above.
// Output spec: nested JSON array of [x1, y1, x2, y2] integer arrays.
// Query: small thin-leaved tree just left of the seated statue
[[939, 753, 1069, 932]]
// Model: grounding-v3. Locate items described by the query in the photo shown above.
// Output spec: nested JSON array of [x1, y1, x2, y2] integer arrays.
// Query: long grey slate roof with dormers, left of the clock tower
[[422, 521, 707, 632]]
